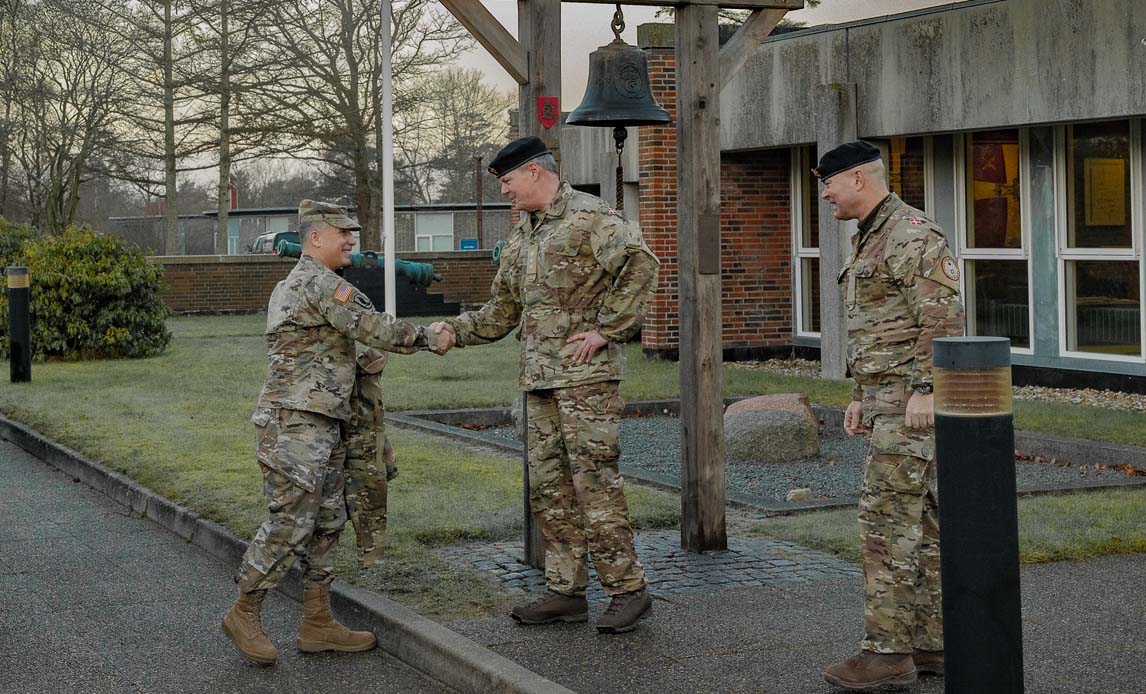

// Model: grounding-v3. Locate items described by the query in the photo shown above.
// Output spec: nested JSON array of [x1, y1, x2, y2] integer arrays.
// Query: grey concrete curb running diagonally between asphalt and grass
[[0, 415, 574, 694]]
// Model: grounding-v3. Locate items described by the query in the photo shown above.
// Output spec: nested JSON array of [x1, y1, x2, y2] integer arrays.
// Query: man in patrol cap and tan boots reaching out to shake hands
[[223, 200, 449, 664]]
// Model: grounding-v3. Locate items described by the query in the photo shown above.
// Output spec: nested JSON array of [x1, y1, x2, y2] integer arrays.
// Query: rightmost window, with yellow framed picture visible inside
[[1059, 120, 1143, 361]]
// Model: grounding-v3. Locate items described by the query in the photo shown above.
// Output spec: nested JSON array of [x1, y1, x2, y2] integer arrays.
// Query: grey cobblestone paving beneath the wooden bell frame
[[439, 530, 861, 601]]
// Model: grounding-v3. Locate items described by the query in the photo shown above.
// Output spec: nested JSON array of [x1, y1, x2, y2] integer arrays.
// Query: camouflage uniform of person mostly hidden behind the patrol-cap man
[[345, 349, 398, 566]]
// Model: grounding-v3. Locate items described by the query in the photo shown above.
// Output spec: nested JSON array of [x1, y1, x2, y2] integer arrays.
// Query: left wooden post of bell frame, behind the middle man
[[517, 0, 562, 569]]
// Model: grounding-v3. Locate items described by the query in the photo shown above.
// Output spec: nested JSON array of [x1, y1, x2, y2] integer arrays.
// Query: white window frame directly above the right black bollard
[[952, 127, 1035, 355]]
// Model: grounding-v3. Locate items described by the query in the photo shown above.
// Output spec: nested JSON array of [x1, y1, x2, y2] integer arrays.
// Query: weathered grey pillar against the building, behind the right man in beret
[[813, 84, 856, 387]]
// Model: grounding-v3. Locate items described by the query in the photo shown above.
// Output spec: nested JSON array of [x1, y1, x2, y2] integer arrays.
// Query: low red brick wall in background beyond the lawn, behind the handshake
[[151, 251, 496, 314]]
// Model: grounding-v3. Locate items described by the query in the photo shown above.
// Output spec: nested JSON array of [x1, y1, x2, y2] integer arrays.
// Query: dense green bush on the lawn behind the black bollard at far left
[[0, 227, 171, 360]]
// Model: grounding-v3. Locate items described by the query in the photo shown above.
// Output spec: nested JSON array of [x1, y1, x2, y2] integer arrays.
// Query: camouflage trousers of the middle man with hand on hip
[[526, 381, 645, 596]]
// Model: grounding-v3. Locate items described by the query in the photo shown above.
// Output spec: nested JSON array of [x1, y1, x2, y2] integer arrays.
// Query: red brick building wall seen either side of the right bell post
[[638, 48, 793, 350]]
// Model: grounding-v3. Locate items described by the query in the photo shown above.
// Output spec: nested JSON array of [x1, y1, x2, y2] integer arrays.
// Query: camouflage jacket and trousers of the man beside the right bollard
[[839, 194, 964, 653]]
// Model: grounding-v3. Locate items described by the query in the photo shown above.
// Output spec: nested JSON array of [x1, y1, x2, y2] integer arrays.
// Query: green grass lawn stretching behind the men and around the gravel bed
[[0, 315, 1146, 617]]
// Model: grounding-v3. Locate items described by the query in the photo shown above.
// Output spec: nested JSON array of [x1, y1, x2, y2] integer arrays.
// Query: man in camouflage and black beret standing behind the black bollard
[[816, 142, 964, 691]]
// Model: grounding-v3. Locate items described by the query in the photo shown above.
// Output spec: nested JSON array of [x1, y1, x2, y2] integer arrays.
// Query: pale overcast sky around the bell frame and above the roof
[[451, 0, 971, 103]]
